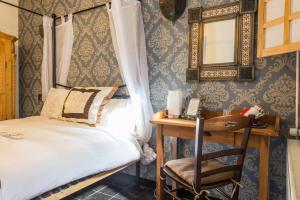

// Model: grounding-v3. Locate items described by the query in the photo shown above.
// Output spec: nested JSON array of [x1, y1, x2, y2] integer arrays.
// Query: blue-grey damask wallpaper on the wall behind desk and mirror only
[[143, 0, 295, 200]]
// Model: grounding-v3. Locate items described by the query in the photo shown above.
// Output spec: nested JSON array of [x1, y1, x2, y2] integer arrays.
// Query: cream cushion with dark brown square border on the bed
[[61, 87, 117, 125]]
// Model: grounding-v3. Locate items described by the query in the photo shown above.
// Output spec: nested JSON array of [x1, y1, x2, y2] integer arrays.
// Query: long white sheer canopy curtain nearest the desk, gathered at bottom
[[107, 0, 156, 164]]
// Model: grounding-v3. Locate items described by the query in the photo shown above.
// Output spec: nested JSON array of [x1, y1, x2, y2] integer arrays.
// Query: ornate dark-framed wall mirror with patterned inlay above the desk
[[187, 0, 256, 82]]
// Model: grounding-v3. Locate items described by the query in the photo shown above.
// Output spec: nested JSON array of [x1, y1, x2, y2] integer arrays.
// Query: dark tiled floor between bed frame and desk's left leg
[[67, 173, 154, 200]]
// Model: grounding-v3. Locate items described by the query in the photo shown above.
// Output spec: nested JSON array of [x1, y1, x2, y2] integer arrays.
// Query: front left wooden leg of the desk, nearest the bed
[[156, 125, 164, 200]]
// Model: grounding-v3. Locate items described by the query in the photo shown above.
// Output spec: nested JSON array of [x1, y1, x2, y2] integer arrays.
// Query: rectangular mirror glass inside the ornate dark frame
[[202, 19, 236, 65]]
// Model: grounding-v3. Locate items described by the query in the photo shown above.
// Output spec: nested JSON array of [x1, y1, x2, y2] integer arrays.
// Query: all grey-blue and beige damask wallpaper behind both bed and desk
[[19, 0, 296, 200]]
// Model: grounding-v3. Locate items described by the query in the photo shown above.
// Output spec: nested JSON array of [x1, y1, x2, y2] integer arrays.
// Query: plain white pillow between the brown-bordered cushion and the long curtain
[[100, 99, 136, 134]]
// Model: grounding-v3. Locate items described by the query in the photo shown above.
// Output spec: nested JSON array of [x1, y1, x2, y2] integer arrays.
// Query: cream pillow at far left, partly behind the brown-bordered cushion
[[41, 88, 69, 119]]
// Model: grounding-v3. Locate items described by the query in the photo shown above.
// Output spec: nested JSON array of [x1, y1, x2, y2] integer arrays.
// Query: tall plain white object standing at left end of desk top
[[167, 90, 183, 118]]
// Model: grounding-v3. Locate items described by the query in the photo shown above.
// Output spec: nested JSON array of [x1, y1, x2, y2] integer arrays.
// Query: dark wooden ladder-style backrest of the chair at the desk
[[194, 115, 254, 191]]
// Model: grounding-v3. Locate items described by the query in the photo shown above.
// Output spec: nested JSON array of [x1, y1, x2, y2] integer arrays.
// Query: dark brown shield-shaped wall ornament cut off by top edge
[[159, 0, 186, 22]]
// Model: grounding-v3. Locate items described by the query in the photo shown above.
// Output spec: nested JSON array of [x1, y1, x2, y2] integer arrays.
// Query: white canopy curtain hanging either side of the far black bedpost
[[42, 14, 74, 101]]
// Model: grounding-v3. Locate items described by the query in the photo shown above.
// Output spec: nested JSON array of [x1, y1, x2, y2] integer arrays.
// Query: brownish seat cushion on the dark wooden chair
[[165, 158, 234, 185]]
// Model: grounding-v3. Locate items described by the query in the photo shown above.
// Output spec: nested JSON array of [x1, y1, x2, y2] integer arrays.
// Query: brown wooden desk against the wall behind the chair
[[151, 111, 280, 200]]
